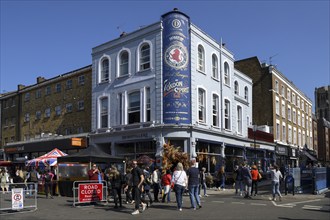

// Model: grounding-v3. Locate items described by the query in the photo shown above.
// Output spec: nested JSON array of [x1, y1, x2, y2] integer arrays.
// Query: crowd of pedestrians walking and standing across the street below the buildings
[[0, 158, 283, 215]]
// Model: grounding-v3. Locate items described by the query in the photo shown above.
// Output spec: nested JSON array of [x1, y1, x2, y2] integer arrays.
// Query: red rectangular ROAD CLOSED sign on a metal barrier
[[78, 183, 103, 202]]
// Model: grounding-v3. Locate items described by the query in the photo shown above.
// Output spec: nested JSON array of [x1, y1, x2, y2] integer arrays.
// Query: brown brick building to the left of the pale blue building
[[0, 65, 92, 161]]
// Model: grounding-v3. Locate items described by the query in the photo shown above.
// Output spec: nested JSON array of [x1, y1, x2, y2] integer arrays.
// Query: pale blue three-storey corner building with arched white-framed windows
[[90, 10, 262, 171]]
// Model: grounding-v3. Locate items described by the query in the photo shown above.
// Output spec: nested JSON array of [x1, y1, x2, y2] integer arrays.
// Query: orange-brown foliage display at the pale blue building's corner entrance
[[162, 143, 189, 172]]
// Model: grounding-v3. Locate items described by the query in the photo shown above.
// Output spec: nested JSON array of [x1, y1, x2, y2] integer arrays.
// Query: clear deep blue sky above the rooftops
[[0, 0, 330, 108]]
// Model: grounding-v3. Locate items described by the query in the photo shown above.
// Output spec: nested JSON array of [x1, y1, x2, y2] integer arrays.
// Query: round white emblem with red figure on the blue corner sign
[[165, 43, 188, 69]]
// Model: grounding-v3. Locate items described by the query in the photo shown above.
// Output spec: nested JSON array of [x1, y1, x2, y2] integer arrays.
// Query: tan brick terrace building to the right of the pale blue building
[[235, 57, 315, 166]]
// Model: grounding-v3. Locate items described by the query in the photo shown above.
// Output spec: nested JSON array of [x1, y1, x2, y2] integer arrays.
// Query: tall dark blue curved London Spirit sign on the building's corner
[[162, 11, 191, 124]]
